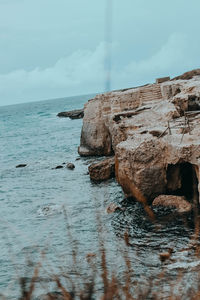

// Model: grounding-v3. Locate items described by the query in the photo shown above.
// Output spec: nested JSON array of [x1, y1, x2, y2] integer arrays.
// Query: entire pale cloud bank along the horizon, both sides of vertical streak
[[0, 33, 199, 105]]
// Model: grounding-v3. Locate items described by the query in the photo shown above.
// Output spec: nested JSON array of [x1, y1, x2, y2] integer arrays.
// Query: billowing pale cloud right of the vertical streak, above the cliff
[[118, 33, 196, 84]]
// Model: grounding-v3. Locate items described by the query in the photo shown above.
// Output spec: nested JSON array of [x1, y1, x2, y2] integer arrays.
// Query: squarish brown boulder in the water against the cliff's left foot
[[88, 157, 115, 182]]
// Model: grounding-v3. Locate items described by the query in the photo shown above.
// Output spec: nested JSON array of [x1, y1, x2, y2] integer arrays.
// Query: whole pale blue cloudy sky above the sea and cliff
[[0, 0, 200, 105]]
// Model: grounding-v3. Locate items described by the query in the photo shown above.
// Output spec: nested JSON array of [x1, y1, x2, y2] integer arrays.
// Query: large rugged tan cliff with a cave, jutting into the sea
[[78, 70, 200, 207]]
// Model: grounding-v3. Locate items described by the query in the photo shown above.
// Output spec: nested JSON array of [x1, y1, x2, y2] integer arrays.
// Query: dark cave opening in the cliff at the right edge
[[167, 162, 199, 203]]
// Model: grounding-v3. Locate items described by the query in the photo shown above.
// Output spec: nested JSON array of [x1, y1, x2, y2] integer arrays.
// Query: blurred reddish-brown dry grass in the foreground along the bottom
[[3, 202, 200, 300]]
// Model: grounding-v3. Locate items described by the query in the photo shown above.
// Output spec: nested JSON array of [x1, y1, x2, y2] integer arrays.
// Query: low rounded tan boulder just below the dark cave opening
[[152, 195, 192, 213]]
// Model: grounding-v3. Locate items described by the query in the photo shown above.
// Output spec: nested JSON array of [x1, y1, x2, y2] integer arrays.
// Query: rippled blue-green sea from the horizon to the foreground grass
[[0, 95, 200, 299]]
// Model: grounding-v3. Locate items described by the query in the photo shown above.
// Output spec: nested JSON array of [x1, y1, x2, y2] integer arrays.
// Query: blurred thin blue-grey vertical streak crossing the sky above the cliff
[[105, 0, 112, 92]]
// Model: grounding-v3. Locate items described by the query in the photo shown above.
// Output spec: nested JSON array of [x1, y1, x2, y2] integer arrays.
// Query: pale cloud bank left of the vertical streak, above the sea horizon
[[0, 43, 105, 105]]
